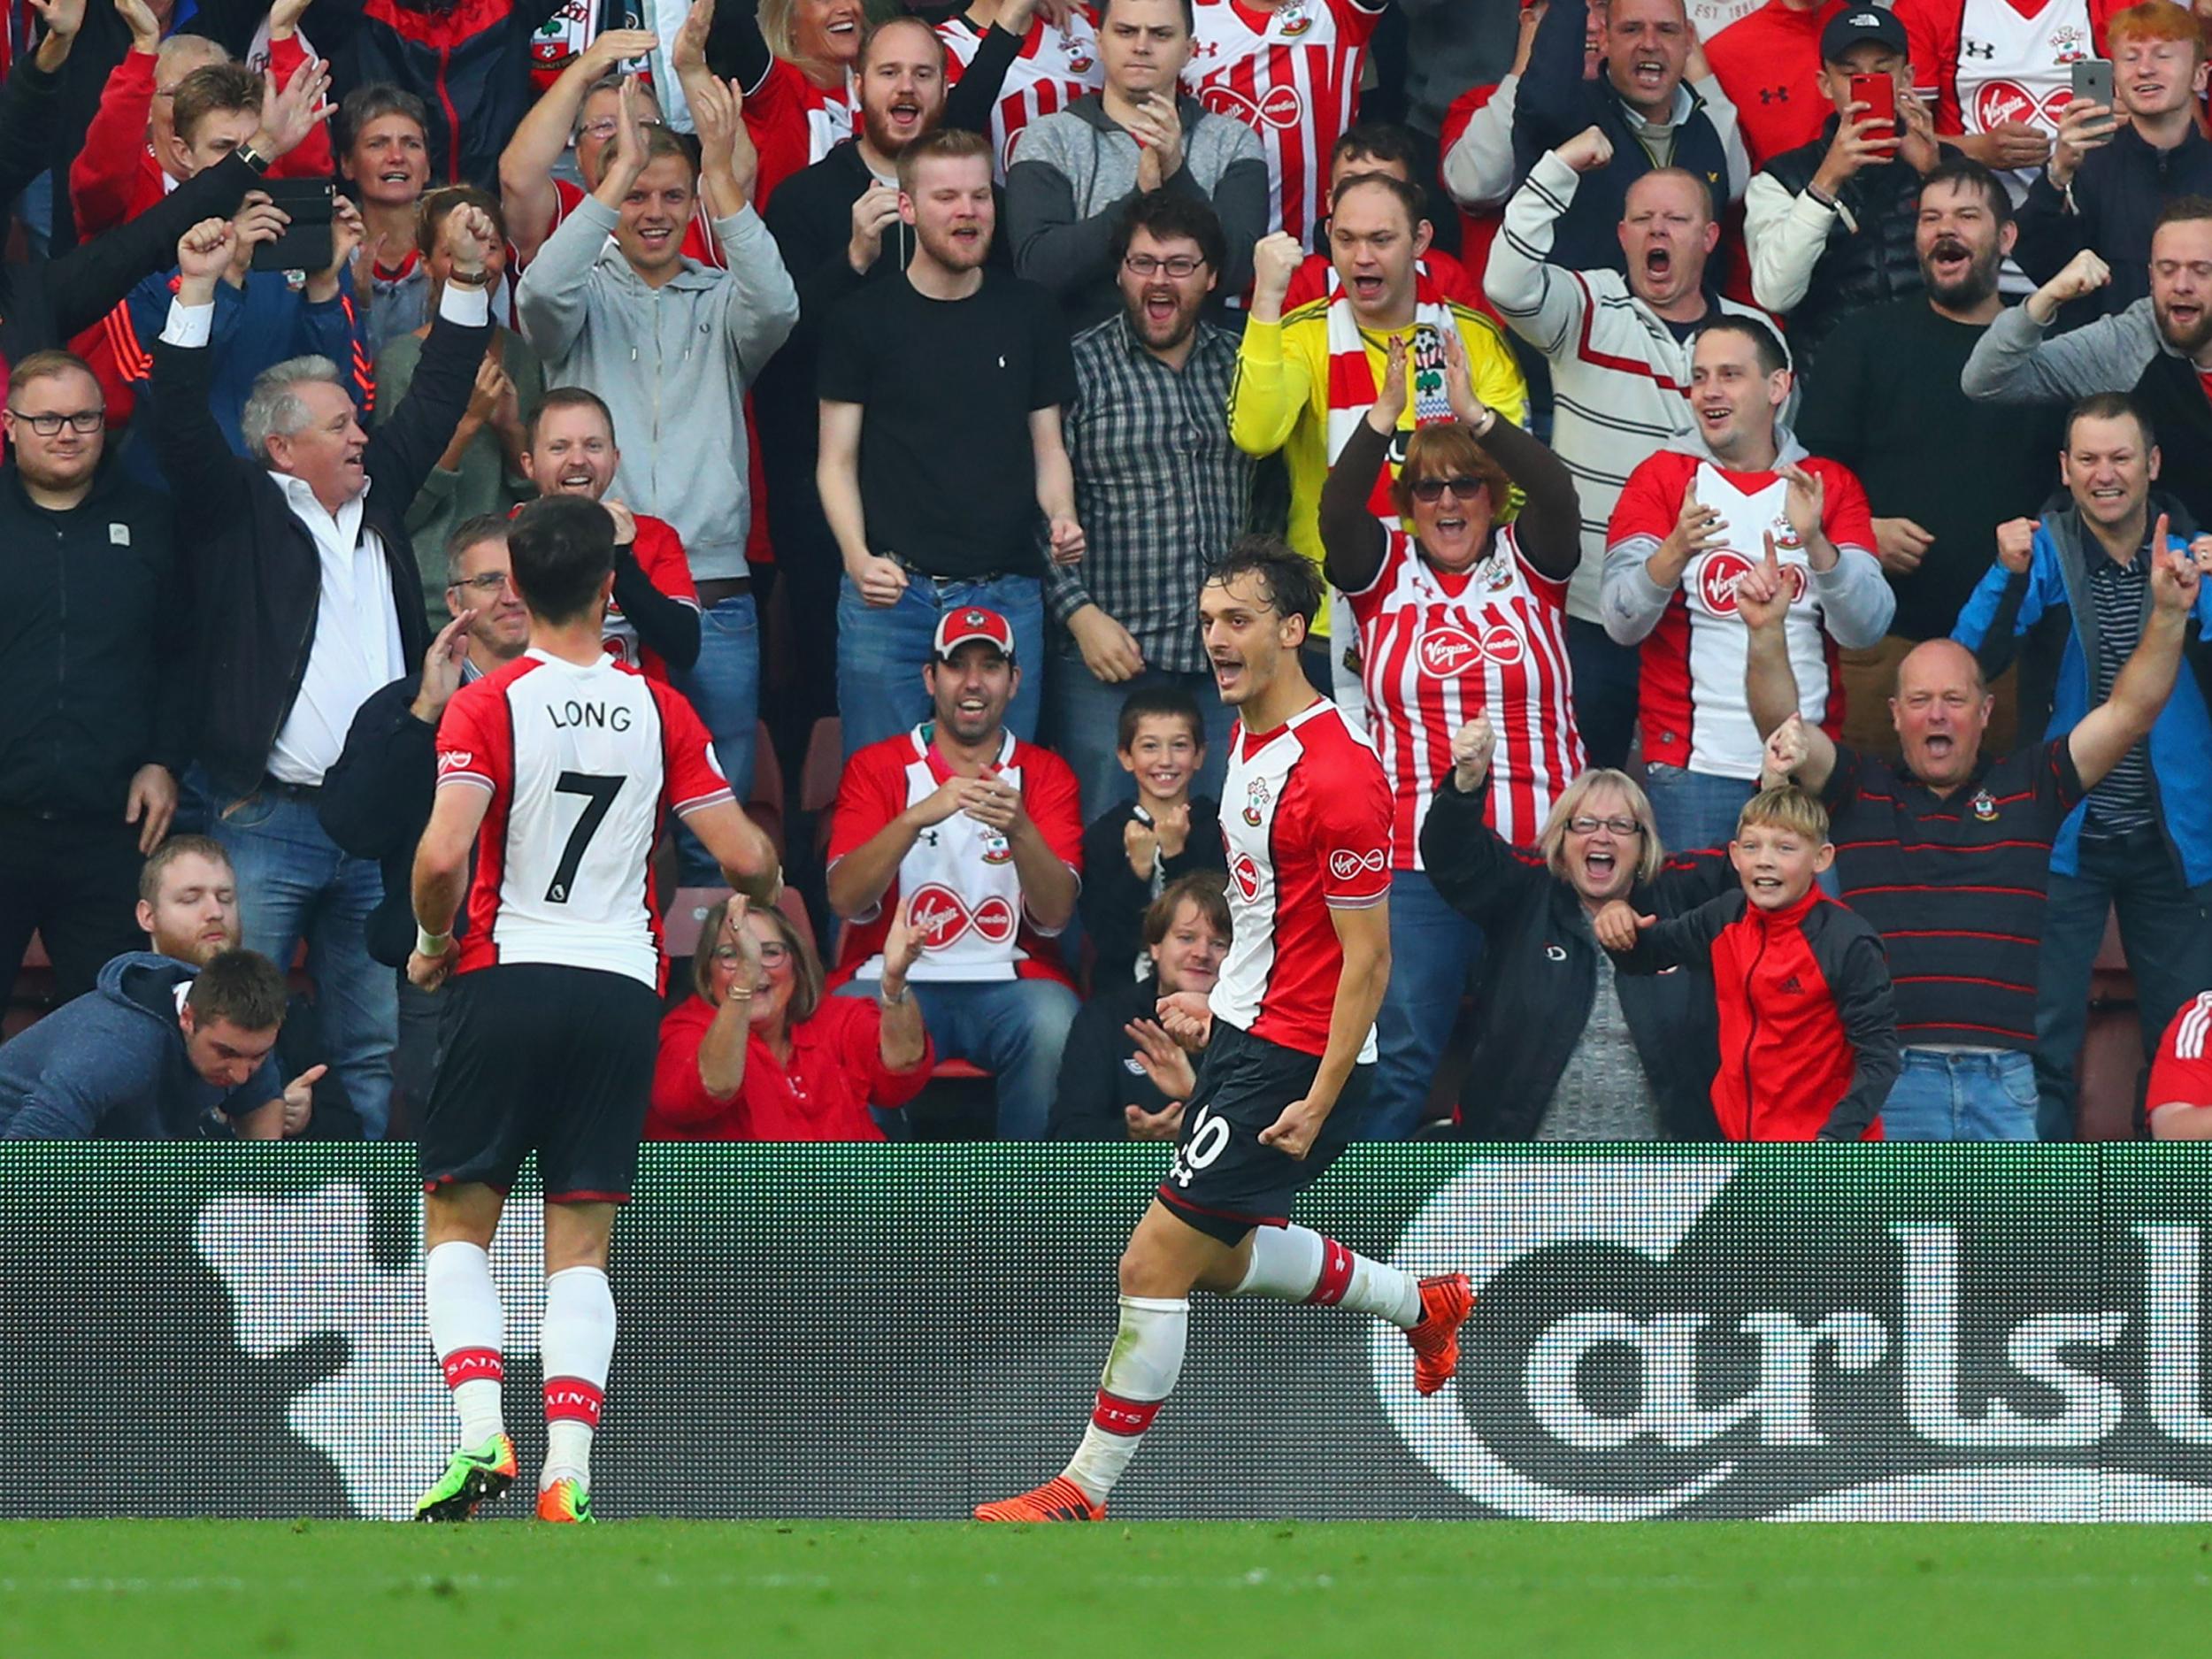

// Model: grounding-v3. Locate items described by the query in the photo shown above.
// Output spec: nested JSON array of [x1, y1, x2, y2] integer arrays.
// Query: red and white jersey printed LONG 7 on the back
[[438, 650, 730, 989]]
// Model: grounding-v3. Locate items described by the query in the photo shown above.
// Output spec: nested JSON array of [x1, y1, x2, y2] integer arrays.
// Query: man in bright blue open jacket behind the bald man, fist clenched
[[1951, 392, 2212, 1140]]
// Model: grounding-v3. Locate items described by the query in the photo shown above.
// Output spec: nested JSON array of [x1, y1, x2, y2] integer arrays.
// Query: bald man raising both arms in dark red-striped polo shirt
[[1737, 571, 2197, 1141]]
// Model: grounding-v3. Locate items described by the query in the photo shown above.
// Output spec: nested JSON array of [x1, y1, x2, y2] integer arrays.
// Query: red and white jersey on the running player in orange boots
[[1208, 697, 1392, 1062]]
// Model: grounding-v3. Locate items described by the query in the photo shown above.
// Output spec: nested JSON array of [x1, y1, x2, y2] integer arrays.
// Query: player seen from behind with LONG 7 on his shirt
[[407, 495, 783, 1522]]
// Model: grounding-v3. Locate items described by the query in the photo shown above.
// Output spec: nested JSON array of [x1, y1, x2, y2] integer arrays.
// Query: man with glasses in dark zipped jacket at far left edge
[[0, 352, 193, 1004]]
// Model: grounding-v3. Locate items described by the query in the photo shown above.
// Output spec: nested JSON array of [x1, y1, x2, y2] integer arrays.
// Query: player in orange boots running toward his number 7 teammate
[[976, 538, 1473, 1522]]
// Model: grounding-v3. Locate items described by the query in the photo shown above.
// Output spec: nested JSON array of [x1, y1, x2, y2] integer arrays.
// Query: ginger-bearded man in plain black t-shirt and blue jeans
[[814, 133, 1084, 759]]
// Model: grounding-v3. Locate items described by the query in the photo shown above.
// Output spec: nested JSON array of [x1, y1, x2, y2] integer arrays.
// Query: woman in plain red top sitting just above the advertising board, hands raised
[[646, 896, 932, 1141]]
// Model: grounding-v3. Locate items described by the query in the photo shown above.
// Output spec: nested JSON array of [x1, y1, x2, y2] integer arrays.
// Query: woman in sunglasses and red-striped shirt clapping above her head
[[1321, 330, 1582, 1140]]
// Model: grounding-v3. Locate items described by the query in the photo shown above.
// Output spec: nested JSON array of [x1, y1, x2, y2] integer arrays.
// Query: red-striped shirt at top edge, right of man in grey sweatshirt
[[1184, 0, 1383, 248]]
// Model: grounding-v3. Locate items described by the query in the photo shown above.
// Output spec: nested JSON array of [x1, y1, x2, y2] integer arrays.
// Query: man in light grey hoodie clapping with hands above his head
[[516, 78, 799, 863]]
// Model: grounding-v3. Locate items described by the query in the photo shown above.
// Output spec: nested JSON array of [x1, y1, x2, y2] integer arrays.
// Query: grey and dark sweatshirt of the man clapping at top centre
[[1007, 93, 1268, 327]]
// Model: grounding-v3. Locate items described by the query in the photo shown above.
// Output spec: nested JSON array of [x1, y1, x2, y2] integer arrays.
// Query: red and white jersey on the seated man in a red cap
[[830, 726, 1084, 985]]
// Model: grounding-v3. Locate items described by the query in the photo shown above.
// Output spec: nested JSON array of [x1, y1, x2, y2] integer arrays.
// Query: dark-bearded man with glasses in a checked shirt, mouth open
[[1044, 190, 1255, 818]]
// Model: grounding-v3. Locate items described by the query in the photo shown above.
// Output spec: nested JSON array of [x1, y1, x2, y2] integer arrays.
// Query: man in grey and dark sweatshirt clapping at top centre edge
[[1007, 0, 1274, 327]]
